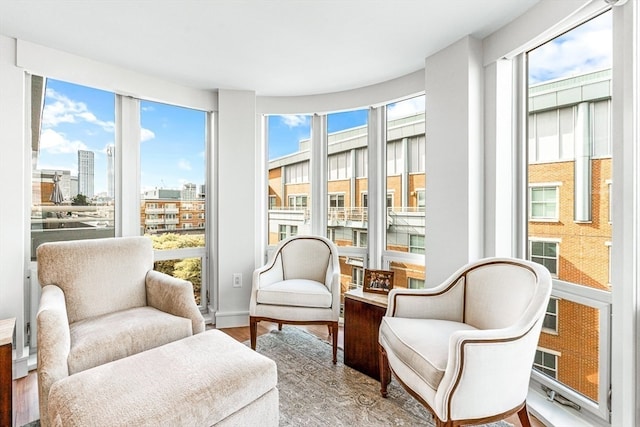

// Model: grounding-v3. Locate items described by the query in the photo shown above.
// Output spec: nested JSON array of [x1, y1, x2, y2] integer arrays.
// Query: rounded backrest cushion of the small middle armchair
[[280, 236, 332, 284]]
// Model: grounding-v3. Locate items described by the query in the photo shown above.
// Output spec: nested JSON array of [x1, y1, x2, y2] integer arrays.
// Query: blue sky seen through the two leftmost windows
[[37, 79, 205, 194]]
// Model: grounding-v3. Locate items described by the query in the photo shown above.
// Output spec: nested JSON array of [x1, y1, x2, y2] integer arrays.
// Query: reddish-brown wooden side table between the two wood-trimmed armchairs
[[344, 289, 388, 381]]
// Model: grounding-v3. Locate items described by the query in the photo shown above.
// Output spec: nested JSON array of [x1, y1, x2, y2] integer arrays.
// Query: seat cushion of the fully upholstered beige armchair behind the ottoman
[[67, 306, 192, 375]]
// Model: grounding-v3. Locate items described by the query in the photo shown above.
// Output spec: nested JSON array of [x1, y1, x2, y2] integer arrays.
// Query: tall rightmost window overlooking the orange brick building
[[526, 11, 616, 419]]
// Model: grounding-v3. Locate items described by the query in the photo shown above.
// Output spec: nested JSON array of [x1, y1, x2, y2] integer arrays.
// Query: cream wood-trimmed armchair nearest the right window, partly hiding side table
[[379, 258, 551, 427]]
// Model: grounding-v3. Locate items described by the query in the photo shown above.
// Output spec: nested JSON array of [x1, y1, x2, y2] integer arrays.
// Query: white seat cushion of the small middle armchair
[[256, 279, 332, 308]]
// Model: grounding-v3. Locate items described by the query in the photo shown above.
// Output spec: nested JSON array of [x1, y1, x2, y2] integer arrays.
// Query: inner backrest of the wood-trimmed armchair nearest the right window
[[464, 261, 538, 329]]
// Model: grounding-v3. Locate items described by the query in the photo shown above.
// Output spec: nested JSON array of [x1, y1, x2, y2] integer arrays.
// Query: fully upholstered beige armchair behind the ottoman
[[37, 237, 204, 427]]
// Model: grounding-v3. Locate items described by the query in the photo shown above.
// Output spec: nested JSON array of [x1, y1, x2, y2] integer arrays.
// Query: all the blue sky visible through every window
[[37, 12, 612, 194]]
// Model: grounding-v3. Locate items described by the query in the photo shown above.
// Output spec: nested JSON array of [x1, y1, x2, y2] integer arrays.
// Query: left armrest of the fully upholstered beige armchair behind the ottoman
[[36, 285, 71, 426]]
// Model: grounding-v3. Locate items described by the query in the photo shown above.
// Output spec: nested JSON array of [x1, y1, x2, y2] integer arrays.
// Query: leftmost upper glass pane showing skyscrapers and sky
[[31, 76, 116, 260]]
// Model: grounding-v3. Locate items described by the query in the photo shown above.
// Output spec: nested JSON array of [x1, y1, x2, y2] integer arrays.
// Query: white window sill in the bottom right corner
[[527, 387, 610, 427]]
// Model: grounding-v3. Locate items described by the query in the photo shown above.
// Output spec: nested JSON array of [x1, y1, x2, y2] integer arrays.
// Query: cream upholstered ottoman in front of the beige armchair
[[49, 330, 279, 427]]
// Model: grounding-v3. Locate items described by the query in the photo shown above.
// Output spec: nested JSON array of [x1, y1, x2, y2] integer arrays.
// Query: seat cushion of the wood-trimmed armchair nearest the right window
[[380, 316, 476, 390]]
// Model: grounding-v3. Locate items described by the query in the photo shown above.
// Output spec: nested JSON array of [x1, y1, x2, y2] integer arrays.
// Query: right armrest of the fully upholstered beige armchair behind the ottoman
[[145, 270, 204, 334]]
